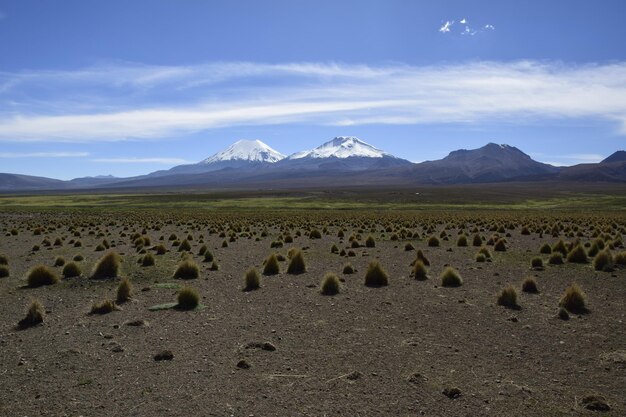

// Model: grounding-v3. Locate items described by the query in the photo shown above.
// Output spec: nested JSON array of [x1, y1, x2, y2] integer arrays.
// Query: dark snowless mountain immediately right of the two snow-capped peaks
[[410, 143, 559, 184]]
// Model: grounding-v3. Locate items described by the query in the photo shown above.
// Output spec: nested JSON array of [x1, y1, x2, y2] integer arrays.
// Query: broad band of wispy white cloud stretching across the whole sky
[[0, 61, 626, 142]]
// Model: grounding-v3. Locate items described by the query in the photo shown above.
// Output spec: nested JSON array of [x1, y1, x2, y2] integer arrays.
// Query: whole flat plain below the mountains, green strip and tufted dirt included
[[0, 185, 626, 416]]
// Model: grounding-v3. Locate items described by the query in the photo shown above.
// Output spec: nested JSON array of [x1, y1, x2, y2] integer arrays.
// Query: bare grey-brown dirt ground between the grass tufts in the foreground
[[0, 212, 626, 417]]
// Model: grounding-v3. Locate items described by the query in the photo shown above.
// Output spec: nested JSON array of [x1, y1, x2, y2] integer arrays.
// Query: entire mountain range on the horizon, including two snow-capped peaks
[[0, 136, 626, 192]]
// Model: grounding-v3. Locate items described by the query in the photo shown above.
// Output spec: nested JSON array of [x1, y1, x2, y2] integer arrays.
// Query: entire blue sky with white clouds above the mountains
[[0, 0, 626, 179]]
